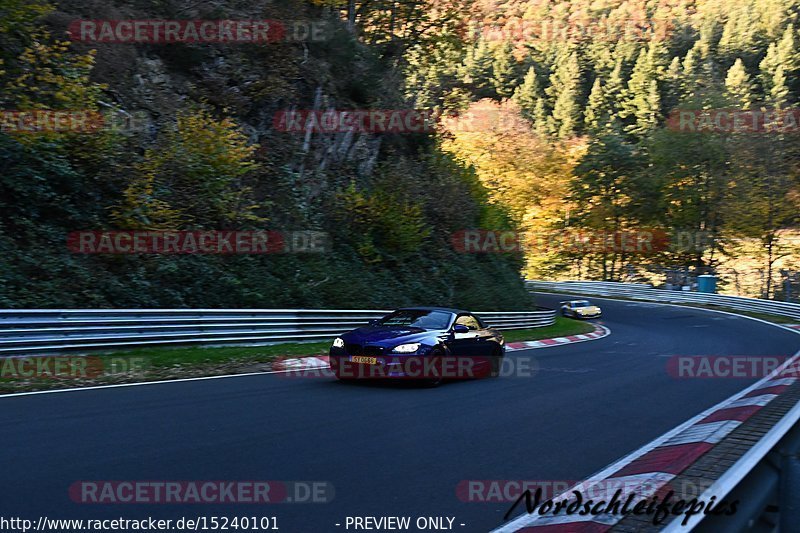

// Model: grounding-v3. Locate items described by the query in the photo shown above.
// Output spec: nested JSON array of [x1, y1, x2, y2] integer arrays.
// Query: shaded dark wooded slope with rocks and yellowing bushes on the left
[[0, 0, 532, 309]]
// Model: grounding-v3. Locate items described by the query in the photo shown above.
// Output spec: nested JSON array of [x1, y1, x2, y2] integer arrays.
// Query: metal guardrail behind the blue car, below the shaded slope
[[0, 308, 556, 355]]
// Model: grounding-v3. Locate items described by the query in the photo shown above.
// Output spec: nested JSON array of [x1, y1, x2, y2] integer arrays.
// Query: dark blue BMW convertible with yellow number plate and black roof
[[330, 307, 505, 385]]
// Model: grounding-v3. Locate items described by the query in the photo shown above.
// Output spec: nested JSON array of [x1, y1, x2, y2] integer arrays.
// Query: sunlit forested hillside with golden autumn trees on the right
[[407, 0, 800, 297]]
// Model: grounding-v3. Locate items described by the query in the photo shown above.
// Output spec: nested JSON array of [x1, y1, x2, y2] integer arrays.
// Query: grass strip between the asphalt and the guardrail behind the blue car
[[0, 316, 594, 394]]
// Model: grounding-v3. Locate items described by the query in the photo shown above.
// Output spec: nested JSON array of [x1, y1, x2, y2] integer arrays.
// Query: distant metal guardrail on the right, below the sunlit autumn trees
[[526, 281, 800, 321]]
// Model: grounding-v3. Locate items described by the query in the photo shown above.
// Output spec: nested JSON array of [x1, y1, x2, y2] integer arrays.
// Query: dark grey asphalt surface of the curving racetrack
[[0, 293, 800, 533]]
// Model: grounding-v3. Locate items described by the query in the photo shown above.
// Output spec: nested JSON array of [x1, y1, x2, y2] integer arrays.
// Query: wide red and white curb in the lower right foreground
[[493, 352, 800, 533]]
